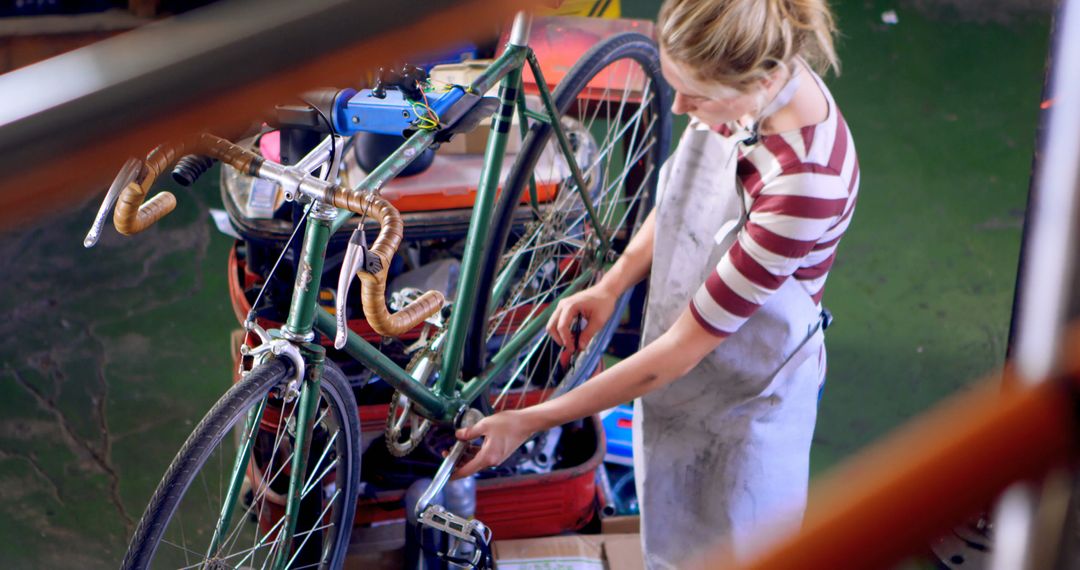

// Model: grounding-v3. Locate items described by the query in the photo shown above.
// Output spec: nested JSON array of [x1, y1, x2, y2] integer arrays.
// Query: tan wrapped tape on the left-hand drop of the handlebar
[[112, 134, 258, 235]]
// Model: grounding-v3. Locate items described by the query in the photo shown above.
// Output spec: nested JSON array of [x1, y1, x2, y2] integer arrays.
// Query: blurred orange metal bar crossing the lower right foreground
[[685, 326, 1080, 570]]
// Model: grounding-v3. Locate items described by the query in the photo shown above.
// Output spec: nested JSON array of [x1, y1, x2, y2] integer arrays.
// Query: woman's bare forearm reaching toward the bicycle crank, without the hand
[[522, 311, 721, 431]]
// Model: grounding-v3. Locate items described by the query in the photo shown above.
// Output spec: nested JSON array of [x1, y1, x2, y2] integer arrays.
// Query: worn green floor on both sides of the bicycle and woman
[[0, 0, 1049, 569]]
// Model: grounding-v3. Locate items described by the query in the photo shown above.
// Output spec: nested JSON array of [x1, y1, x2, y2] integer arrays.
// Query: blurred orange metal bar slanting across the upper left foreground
[[0, 0, 540, 228]]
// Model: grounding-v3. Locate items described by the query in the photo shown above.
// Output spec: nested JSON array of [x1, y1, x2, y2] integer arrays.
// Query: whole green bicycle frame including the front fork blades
[[232, 28, 610, 568]]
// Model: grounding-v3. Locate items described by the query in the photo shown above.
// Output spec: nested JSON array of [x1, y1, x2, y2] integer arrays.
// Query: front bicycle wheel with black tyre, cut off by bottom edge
[[122, 358, 360, 569]]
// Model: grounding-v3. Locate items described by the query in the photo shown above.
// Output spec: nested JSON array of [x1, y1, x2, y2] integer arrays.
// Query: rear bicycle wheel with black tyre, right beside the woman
[[464, 33, 671, 409]]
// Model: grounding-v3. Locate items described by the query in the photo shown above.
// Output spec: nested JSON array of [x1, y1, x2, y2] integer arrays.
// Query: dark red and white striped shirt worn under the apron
[[690, 78, 859, 337]]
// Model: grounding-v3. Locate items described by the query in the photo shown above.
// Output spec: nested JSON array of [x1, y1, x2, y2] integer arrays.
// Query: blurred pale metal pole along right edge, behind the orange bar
[[989, 0, 1080, 570]]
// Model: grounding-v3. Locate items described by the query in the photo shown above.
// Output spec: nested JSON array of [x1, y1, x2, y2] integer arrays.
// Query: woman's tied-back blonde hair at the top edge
[[657, 0, 840, 91]]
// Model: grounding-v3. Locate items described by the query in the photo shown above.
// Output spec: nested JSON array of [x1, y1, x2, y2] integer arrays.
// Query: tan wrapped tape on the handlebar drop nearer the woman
[[326, 186, 446, 337]]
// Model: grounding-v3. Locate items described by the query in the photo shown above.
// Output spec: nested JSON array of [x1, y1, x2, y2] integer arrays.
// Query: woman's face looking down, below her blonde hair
[[660, 50, 765, 127]]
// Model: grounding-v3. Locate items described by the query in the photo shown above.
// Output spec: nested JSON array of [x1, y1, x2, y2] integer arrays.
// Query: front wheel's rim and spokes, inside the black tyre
[[143, 375, 353, 568]]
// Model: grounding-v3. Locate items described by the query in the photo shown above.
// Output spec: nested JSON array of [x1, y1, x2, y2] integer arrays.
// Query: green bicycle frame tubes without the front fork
[[313, 45, 610, 423]]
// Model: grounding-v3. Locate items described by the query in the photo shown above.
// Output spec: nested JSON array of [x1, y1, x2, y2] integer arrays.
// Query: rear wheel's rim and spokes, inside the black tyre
[[487, 54, 664, 409]]
